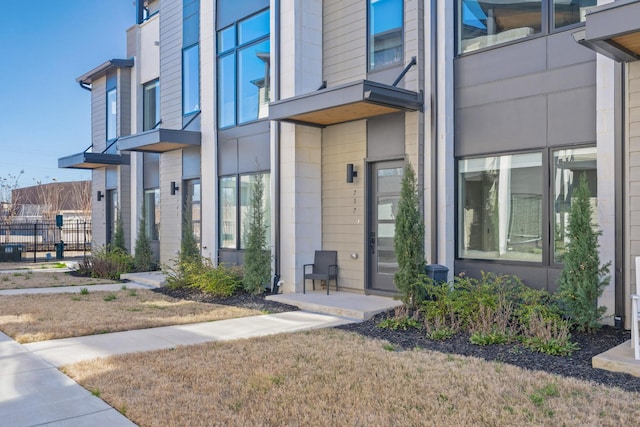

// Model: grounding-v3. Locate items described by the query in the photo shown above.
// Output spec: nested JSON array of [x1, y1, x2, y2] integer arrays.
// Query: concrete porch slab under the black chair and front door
[[266, 291, 402, 320]]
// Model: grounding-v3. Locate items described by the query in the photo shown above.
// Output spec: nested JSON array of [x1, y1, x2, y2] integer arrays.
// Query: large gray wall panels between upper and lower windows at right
[[455, 32, 596, 156]]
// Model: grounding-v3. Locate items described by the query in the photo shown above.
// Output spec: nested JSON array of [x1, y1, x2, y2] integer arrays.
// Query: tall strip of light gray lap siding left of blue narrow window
[[160, 1, 182, 129]]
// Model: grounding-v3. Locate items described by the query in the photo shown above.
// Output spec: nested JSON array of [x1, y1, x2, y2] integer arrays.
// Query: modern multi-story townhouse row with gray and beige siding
[[59, 0, 640, 328]]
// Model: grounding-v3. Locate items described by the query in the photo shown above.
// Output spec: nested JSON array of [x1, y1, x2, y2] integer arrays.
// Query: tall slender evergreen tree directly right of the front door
[[393, 162, 424, 307]]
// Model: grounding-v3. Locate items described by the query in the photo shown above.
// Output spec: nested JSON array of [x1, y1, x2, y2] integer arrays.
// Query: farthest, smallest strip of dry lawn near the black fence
[[0, 270, 114, 290]]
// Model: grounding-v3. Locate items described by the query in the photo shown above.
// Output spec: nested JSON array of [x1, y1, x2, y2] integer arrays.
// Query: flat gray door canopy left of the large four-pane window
[[118, 128, 202, 153]]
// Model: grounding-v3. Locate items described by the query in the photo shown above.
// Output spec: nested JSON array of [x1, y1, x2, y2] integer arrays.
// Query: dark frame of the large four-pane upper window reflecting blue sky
[[215, 7, 271, 130]]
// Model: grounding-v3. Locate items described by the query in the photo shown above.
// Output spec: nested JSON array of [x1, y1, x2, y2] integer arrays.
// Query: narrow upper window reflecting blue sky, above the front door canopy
[[368, 0, 404, 71]]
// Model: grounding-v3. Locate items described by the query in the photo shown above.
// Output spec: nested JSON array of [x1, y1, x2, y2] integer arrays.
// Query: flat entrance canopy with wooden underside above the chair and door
[[269, 80, 423, 127]]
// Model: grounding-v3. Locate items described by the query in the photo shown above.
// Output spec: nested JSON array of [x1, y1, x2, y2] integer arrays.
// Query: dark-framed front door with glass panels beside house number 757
[[367, 160, 404, 292]]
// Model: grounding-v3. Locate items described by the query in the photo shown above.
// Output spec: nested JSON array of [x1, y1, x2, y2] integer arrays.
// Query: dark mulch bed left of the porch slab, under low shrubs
[[154, 286, 299, 313]]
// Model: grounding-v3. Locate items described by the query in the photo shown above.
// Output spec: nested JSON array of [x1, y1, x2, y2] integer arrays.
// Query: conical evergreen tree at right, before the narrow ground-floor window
[[559, 174, 611, 332]]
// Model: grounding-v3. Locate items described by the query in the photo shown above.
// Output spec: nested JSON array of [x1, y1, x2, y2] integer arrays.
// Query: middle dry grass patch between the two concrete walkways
[[0, 288, 262, 343]]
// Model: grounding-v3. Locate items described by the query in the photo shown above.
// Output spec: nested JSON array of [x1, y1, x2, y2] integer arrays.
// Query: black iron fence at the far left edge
[[0, 219, 91, 261]]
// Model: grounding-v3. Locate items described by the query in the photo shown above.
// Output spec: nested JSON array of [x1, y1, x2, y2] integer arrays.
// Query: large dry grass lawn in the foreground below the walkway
[[63, 330, 640, 427]]
